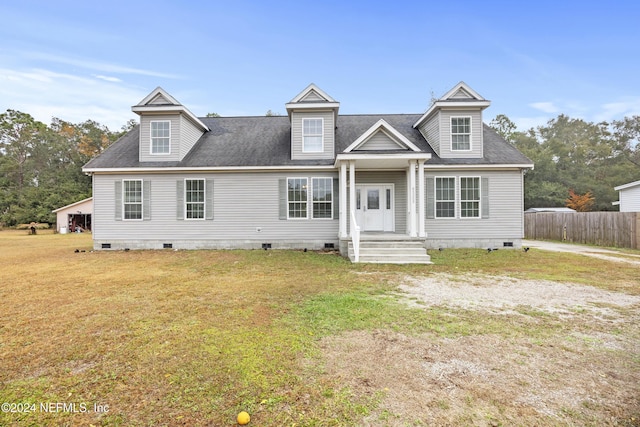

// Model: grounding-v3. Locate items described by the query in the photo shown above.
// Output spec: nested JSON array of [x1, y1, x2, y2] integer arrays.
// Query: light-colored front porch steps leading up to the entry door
[[348, 240, 431, 264]]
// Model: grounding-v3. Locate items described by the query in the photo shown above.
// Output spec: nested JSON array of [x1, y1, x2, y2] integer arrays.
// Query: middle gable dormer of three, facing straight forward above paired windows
[[286, 83, 340, 160]]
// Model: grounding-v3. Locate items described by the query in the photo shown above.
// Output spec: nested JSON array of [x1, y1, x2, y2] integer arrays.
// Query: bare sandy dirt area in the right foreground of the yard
[[322, 274, 640, 426]]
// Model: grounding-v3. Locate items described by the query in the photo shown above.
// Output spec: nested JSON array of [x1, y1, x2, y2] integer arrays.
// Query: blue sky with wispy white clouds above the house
[[0, 0, 640, 131]]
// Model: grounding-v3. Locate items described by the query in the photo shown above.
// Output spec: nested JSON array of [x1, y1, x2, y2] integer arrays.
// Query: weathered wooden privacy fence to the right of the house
[[524, 212, 640, 249]]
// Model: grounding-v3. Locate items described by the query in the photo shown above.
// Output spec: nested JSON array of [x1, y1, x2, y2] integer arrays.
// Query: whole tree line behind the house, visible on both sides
[[0, 110, 640, 226]]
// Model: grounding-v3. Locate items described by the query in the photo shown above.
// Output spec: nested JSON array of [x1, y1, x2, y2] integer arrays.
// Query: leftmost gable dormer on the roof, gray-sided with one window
[[131, 87, 209, 162]]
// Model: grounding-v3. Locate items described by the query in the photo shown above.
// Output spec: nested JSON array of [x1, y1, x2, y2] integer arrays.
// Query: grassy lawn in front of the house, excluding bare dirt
[[0, 231, 639, 426]]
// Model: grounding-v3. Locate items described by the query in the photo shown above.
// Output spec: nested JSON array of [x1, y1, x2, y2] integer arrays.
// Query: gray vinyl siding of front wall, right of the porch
[[425, 170, 524, 240]]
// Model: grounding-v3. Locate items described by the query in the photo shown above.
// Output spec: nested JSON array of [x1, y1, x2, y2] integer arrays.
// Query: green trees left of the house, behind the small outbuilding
[[0, 109, 135, 227]]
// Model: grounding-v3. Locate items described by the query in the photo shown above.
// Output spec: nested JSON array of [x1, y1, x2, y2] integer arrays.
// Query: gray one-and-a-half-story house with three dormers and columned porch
[[83, 82, 533, 262]]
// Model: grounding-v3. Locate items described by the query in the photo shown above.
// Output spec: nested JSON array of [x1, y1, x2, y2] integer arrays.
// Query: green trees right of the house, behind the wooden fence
[[489, 114, 640, 211]]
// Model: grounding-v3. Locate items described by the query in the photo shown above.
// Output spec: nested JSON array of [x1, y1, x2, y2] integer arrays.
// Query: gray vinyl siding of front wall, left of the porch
[[93, 171, 338, 247]]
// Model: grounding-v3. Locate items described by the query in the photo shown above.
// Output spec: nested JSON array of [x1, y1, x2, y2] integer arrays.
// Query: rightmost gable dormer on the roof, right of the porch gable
[[413, 82, 491, 159]]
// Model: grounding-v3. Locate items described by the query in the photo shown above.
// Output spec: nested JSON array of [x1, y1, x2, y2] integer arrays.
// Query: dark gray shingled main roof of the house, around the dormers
[[84, 114, 532, 170]]
